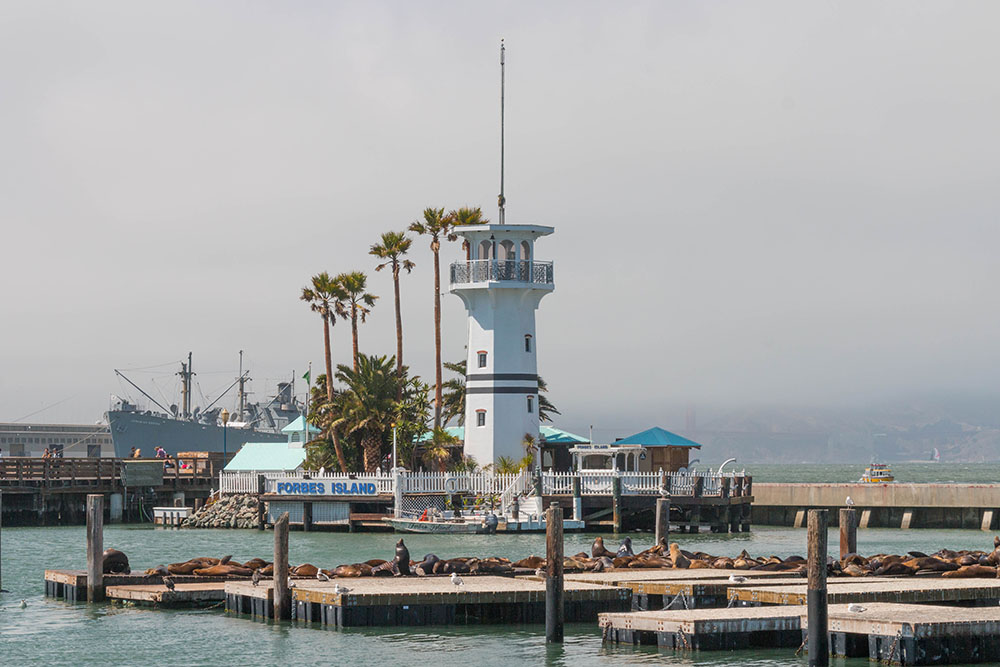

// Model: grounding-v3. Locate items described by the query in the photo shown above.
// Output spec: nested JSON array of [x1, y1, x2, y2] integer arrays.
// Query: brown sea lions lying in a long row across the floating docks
[[117, 537, 1000, 582]]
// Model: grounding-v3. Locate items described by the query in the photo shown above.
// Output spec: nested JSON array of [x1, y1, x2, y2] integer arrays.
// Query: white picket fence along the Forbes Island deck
[[219, 470, 743, 498]]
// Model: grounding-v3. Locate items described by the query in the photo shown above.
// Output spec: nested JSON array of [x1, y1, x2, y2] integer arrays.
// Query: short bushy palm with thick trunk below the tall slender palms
[[331, 354, 399, 472]]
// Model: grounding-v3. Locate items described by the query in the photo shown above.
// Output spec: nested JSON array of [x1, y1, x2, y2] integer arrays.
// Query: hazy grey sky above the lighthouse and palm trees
[[0, 0, 1000, 438]]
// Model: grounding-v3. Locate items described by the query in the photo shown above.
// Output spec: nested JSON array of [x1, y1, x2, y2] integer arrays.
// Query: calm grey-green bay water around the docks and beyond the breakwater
[[0, 464, 1000, 667]]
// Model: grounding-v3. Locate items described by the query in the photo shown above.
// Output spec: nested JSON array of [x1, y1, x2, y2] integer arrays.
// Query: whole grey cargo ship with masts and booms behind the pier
[[106, 352, 302, 457]]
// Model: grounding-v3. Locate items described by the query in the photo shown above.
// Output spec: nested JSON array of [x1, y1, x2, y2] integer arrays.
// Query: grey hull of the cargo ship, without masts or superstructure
[[107, 410, 287, 458]]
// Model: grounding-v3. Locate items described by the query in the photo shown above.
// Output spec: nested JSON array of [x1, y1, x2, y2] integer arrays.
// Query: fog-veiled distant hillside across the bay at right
[[684, 405, 1000, 463]]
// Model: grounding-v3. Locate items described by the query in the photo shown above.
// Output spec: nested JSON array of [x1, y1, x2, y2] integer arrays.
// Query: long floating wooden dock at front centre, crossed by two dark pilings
[[225, 575, 632, 628]]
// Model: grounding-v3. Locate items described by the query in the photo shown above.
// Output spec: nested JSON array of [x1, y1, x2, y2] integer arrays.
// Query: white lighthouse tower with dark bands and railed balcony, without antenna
[[451, 224, 555, 465]]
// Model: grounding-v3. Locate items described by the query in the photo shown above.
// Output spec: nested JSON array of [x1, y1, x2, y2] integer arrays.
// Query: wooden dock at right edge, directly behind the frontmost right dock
[[731, 577, 1000, 605]]
